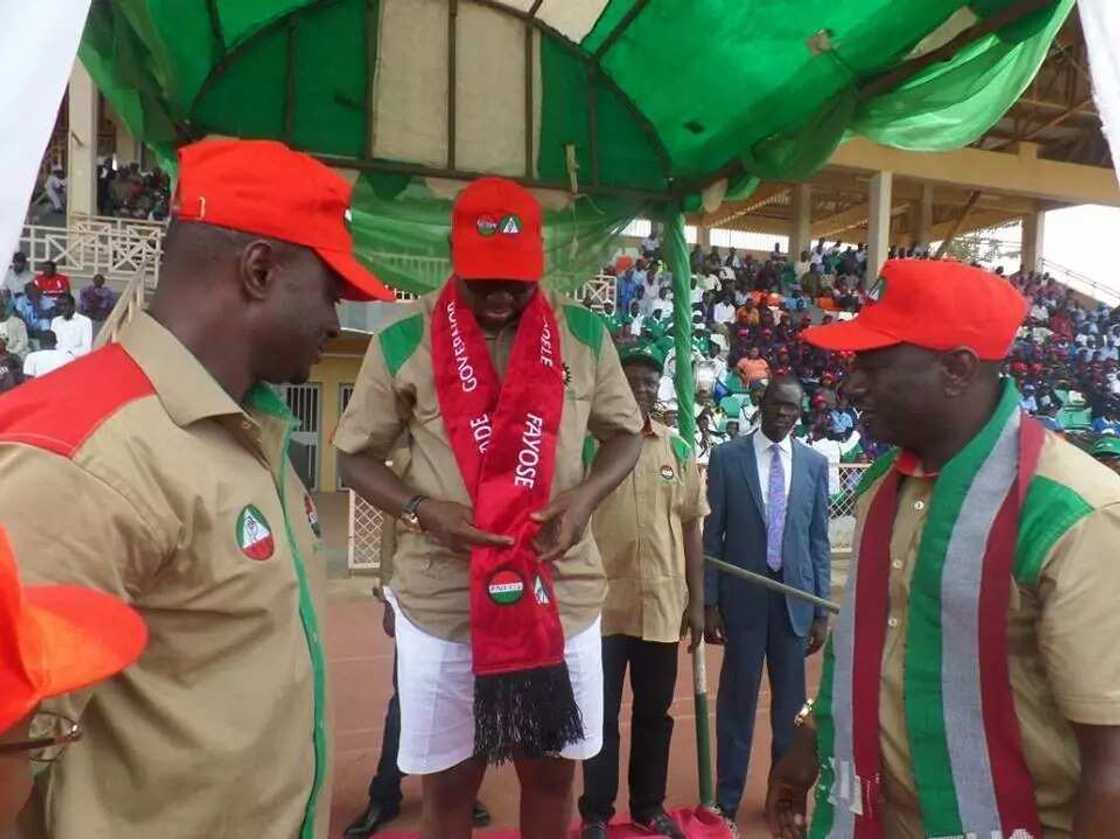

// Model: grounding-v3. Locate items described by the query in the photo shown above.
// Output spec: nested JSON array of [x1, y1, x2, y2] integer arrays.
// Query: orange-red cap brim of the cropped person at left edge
[[24, 586, 148, 698]]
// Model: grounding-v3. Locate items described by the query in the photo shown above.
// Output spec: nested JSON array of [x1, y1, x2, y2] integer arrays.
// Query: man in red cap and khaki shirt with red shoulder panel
[[0, 140, 389, 839]]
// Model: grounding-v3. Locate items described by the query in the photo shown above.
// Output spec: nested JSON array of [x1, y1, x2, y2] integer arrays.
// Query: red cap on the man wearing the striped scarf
[[802, 259, 1027, 361]]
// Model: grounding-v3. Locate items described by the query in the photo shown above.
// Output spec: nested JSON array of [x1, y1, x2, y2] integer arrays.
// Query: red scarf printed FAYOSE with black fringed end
[[431, 277, 584, 763]]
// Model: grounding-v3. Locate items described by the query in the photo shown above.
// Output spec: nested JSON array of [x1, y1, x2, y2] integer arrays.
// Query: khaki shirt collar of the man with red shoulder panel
[[120, 313, 256, 427]]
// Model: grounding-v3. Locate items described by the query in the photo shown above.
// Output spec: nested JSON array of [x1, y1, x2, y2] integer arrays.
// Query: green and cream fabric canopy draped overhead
[[80, 0, 1073, 452]]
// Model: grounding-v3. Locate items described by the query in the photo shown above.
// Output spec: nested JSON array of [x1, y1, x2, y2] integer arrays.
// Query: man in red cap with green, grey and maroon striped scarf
[[767, 260, 1120, 839]]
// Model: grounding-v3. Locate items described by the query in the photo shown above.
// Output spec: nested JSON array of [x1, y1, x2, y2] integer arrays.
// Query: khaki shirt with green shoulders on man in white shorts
[[334, 293, 642, 642]]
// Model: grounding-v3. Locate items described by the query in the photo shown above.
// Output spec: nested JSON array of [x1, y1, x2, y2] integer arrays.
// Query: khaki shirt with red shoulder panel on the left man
[[0, 315, 330, 839]]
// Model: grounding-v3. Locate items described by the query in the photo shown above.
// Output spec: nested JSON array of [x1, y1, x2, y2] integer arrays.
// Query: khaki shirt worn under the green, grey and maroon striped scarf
[[857, 434, 1120, 839]]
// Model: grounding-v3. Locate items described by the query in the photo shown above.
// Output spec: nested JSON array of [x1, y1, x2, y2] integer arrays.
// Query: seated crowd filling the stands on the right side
[[604, 234, 1120, 483]]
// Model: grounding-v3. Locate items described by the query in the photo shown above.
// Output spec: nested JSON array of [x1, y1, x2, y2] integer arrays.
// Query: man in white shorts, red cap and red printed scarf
[[335, 178, 642, 839]]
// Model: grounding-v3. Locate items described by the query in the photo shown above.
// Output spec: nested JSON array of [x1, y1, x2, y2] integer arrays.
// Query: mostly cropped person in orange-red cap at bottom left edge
[[0, 529, 148, 836]]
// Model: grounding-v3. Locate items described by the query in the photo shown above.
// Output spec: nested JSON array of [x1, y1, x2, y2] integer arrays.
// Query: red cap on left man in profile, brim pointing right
[[172, 140, 393, 300]]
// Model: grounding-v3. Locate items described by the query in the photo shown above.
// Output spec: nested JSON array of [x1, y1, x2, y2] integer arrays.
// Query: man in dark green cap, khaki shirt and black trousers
[[579, 344, 708, 839]]
